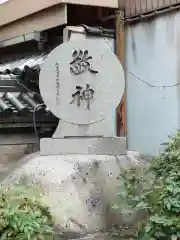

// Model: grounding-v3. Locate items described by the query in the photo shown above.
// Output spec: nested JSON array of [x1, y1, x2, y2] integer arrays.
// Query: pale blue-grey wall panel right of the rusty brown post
[[126, 11, 180, 154]]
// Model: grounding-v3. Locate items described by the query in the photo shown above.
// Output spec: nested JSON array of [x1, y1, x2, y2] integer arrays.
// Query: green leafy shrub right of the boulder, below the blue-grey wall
[[115, 131, 180, 240]]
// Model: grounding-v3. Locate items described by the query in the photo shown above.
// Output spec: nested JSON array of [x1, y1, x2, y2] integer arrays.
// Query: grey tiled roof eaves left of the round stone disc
[[0, 53, 49, 117]]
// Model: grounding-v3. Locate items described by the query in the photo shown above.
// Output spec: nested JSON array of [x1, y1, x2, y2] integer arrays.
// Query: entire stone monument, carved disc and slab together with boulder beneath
[[2, 40, 140, 236]]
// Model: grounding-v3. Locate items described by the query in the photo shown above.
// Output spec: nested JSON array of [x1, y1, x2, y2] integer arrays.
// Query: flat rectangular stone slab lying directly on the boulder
[[40, 137, 126, 156]]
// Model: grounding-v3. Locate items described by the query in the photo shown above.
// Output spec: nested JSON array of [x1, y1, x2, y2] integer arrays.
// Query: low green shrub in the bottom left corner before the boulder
[[0, 186, 59, 240]]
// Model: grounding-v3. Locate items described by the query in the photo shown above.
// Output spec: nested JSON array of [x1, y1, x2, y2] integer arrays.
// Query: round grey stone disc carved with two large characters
[[39, 40, 125, 125]]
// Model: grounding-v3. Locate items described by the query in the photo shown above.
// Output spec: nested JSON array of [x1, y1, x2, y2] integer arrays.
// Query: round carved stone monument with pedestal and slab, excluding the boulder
[[40, 40, 126, 155]]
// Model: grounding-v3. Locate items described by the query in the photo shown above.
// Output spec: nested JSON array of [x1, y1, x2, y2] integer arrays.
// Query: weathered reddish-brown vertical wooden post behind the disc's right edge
[[116, 3, 127, 136]]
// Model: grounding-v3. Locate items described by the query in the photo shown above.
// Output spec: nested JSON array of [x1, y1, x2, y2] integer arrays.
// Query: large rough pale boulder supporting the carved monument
[[2, 152, 151, 234]]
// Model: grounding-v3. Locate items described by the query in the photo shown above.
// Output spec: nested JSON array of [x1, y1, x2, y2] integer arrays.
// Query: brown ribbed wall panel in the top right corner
[[125, 0, 180, 18]]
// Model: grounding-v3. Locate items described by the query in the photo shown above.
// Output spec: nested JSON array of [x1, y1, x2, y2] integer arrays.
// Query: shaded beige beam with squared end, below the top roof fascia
[[0, 4, 67, 41]]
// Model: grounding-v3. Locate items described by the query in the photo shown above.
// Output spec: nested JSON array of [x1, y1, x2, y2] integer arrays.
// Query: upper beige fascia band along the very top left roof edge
[[0, 0, 118, 26]]
